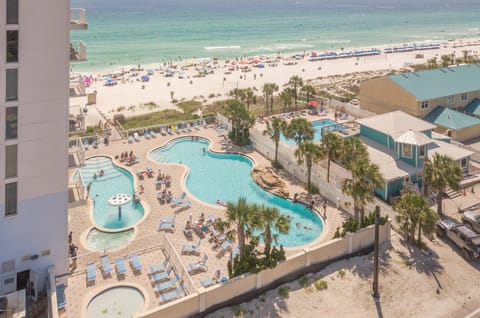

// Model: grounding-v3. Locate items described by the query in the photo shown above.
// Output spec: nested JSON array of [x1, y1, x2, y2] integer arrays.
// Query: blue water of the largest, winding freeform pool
[[151, 138, 323, 247]]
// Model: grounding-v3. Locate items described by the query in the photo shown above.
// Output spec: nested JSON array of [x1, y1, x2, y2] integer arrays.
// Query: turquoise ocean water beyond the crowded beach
[[71, 0, 480, 71]]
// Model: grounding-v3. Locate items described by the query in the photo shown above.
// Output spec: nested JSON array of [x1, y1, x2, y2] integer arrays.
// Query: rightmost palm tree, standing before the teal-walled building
[[423, 153, 463, 216]]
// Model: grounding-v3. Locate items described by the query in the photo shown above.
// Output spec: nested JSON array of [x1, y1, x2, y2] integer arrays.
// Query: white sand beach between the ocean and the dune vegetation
[[70, 38, 480, 125]]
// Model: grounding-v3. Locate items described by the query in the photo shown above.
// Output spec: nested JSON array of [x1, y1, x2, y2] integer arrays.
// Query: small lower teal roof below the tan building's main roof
[[424, 106, 480, 130]]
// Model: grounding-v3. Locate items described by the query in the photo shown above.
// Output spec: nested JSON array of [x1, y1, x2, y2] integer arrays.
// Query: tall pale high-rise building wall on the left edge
[[0, 0, 87, 308]]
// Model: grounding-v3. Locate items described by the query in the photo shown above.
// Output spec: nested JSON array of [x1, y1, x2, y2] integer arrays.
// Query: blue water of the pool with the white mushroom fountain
[[80, 157, 144, 229]]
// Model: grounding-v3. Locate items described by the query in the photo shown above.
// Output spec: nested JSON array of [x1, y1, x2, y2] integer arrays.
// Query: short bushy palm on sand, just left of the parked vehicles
[[393, 192, 438, 246]]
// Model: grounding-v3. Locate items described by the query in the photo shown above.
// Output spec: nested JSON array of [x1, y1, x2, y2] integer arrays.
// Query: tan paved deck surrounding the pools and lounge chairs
[[60, 116, 347, 317]]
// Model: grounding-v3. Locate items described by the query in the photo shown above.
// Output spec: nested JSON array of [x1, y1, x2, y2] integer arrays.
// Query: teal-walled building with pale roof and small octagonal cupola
[[357, 111, 472, 201]]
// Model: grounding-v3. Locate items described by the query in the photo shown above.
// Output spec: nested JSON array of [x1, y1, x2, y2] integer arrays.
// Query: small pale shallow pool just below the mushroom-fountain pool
[[86, 228, 134, 251]]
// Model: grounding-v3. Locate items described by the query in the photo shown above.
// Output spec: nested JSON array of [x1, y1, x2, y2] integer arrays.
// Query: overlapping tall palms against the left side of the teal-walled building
[[342, 138, 384, 222]]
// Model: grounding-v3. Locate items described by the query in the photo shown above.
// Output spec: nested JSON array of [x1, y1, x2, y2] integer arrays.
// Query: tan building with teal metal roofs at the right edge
[[359, 64, 480, 141]]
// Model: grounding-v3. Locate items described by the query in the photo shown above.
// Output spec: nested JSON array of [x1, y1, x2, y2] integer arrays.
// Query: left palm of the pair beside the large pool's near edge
[[218, 197, 259, 258]]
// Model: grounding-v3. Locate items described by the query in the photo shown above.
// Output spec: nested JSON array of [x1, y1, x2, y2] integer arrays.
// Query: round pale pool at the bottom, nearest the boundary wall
[[87, 286, 145, 318]]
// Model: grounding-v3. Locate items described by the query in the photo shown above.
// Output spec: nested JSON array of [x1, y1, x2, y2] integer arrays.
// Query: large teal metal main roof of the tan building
[[388, 64, 480, 100]]
